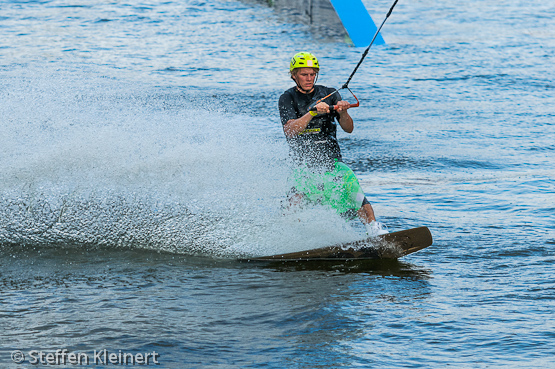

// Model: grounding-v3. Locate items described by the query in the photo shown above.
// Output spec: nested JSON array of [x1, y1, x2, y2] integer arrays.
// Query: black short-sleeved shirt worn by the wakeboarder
[[279, 85, 341, 167]]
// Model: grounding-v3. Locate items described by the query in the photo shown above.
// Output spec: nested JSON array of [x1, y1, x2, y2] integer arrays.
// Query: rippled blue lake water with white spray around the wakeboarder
[[0, 0, 555, 368]]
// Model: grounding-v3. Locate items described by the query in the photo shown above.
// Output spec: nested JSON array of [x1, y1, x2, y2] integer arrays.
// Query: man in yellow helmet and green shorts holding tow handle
[[279, 52, 388, 236]]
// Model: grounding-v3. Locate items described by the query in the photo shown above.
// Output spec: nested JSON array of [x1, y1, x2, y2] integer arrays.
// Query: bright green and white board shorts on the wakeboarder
[[290, 161, 368, 214]]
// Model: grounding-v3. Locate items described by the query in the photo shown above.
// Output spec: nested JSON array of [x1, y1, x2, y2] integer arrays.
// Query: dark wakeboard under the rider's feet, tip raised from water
[[248, 227, 433, 261]]
